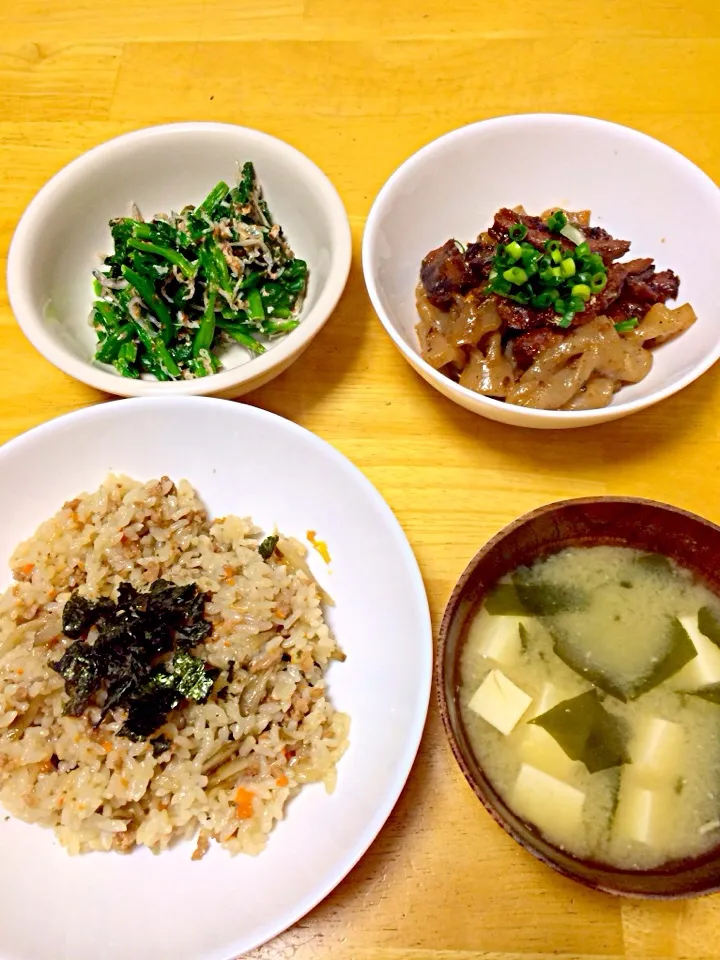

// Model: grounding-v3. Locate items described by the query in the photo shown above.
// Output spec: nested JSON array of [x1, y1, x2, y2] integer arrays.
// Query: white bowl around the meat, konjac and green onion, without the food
[[363, 114, 720, 429]]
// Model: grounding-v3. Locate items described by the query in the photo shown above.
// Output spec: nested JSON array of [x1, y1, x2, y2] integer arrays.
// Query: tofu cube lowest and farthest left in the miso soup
[[511, 763, 585, 835]]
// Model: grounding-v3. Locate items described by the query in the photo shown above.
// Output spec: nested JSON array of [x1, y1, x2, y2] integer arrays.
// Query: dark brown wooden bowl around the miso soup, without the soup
[[436, 497, 720, 899]]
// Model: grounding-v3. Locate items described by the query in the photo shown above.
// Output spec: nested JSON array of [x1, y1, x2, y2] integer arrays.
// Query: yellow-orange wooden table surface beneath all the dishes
[[0, 0, 720, 960]]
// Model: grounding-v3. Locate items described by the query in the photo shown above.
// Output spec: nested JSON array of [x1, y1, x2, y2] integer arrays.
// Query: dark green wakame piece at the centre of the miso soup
[[529, 690, 630, 773]]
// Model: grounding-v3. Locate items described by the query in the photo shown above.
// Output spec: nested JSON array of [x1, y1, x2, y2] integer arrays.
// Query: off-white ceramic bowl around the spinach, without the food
[[7, 123, 351, 397]]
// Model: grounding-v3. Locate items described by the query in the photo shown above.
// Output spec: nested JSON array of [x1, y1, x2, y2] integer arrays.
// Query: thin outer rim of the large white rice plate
[[0, 396, 435, 956]]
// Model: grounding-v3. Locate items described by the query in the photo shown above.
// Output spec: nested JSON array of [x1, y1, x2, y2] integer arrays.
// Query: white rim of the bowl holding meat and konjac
[[362, 111, 720, 426]]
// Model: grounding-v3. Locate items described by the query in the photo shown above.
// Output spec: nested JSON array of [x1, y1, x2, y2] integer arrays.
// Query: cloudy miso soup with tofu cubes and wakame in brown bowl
[[460, 547, 720, 869]]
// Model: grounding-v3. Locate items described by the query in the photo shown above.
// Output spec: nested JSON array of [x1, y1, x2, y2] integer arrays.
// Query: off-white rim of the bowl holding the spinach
[[6, 120, 352, 396]]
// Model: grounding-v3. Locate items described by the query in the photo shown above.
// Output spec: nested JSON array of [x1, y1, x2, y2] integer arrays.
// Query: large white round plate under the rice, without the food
[[0, 397, 432, 960]]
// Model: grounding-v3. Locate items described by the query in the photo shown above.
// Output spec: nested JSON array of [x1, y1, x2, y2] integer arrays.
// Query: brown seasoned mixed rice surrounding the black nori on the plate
[[0, 476, 349, 857]]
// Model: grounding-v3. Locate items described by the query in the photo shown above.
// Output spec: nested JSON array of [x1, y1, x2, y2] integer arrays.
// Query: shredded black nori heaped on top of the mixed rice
[[50, 580, 218, 740]]
